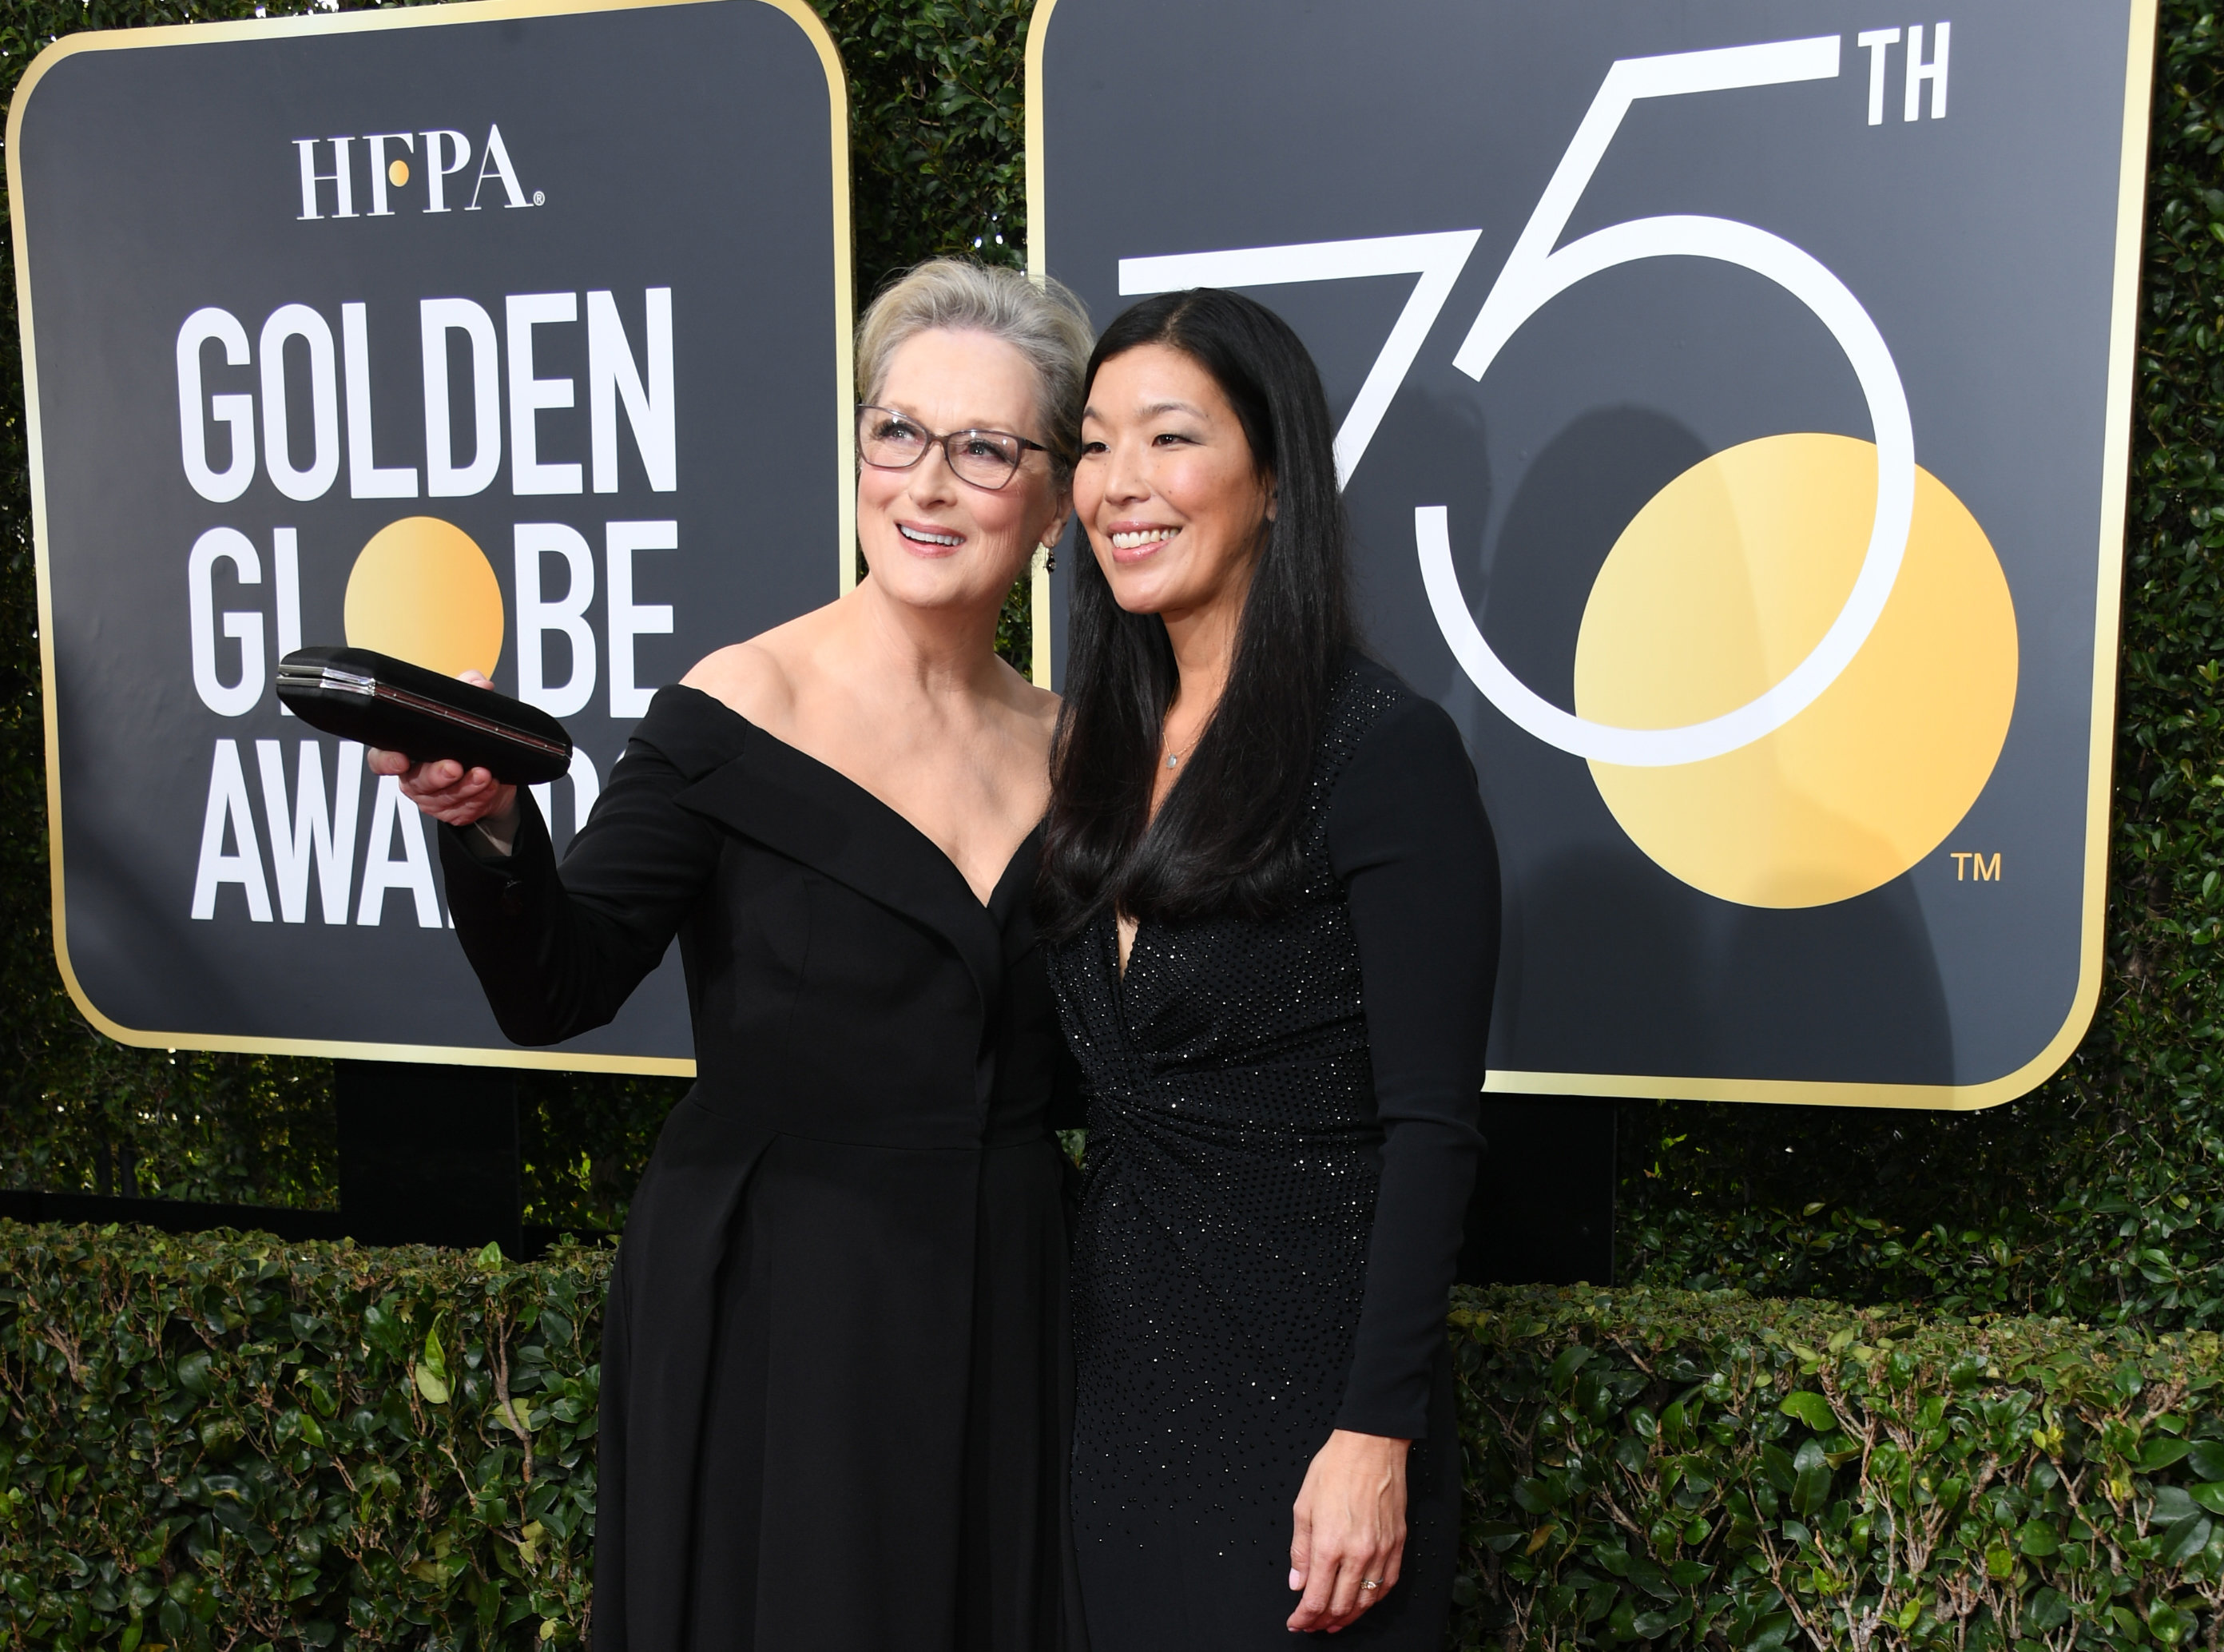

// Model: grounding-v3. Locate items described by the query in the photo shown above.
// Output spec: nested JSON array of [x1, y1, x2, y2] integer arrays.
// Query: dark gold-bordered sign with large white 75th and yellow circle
[[1027, 0, 2153, 1107]]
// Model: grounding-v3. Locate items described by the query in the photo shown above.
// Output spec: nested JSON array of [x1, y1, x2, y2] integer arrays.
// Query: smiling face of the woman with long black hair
[[1074, 344, 1274, 618]]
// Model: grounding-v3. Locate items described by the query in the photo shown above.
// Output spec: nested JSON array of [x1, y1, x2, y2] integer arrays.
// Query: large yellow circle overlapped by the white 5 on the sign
[[1575, 434, 2017, 907]]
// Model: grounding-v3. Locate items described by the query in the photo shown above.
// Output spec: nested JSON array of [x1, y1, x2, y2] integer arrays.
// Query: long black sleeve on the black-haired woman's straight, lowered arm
[[1328, 696, 1499, 1439]]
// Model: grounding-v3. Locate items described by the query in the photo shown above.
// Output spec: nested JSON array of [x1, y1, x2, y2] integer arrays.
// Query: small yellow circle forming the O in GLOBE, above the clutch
[[345, 516, 502, 676]]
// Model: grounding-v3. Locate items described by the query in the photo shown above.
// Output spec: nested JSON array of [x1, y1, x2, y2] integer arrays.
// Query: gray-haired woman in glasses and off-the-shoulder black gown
[[371, 260, 1090, 1652]]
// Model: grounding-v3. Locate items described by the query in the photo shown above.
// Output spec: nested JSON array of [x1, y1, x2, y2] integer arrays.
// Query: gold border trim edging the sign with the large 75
[[1031, 0, 2157, 1112]]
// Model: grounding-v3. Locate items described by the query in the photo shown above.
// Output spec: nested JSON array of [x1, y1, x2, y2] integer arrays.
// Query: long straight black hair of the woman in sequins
[[1036, 287, 1352, 936]]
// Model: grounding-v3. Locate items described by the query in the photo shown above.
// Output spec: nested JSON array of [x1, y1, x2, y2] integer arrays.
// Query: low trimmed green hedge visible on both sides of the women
[[22, 1223, 2224, 1652]]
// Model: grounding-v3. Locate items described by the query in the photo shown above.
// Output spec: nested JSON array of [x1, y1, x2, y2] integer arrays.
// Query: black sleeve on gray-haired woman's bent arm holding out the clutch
[[440, 711, 718, 1045]]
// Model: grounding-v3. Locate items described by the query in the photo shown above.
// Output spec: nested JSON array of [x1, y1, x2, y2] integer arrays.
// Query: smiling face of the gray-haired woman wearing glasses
[[856, 329, 1066, 610]]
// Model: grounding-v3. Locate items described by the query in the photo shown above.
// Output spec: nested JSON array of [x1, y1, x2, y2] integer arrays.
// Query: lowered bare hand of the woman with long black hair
[[1290, 1428, 1412, 1634]]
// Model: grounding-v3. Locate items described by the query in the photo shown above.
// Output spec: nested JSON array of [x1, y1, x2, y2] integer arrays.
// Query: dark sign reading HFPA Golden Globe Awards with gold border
[[6, 0, 849, 1072]]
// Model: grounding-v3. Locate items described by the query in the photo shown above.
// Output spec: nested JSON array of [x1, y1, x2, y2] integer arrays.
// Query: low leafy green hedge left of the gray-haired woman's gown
[[0, 1223, 607, 1652]]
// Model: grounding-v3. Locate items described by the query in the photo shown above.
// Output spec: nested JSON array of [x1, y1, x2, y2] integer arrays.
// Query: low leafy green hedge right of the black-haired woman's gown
[[1452, 1288, 2224, 1652]]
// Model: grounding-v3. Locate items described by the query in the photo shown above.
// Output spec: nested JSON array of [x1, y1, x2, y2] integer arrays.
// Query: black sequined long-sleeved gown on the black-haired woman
[[1050, 656, 1499, 1652]]
